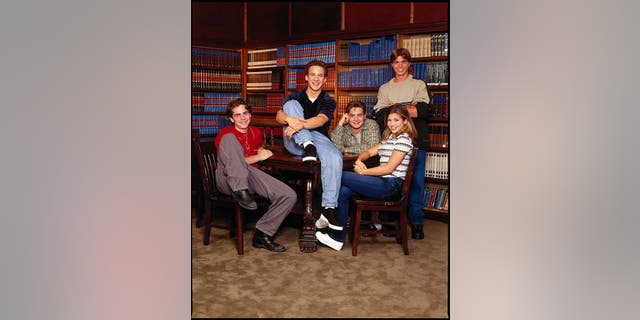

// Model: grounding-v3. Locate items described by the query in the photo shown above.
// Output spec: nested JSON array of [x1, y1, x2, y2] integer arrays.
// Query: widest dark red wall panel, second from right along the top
[[345, 2, 411, 32]]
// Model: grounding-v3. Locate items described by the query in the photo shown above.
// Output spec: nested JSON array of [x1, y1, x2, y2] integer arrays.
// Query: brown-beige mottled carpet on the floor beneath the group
[[192, 210, 448, 318]]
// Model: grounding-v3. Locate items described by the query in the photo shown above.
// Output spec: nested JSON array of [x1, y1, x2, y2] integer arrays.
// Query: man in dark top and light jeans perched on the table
[[276, 60, 342, 235]]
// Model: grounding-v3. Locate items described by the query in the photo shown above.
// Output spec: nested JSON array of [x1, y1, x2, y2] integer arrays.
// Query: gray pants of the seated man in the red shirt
[[216, 133, 296, 236]]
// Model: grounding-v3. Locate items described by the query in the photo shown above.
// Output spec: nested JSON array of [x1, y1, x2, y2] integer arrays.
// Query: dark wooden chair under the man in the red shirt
[[195, 139, 265, 254]]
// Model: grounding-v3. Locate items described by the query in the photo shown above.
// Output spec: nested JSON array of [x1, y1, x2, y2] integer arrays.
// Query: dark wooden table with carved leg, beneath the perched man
[[260, 145, 357, 253]]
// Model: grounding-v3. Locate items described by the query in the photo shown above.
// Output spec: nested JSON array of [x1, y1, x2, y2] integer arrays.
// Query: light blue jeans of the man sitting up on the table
[[282, 100, 342, 207]]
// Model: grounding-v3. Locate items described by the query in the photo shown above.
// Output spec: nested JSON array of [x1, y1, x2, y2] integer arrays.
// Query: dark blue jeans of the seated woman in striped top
[[336, 171, 403, 241]]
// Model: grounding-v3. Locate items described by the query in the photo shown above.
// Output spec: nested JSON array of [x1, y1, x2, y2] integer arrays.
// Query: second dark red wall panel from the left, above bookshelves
[[247, 1, 289, 48]]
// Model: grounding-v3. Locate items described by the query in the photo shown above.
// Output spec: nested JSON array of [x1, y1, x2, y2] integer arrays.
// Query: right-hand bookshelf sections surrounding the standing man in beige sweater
[[331, 30, 449, 221]]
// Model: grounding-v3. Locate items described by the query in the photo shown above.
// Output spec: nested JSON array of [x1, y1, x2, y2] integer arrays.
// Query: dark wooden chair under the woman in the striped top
[[351, 148, 418, 256]]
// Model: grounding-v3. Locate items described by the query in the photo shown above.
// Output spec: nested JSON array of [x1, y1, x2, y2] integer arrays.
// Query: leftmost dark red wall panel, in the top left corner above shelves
[[191, 1, 244, 48]]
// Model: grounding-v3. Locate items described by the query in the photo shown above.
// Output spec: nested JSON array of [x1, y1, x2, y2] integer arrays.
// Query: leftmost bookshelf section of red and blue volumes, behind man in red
[[191, 46, 243, 136]]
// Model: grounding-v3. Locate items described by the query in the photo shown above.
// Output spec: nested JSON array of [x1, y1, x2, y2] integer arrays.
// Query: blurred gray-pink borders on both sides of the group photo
[[0, 0, 640, 320]]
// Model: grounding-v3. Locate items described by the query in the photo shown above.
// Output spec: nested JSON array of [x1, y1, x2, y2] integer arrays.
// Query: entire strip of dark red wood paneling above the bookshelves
[[191, 1, 449, 49]]
